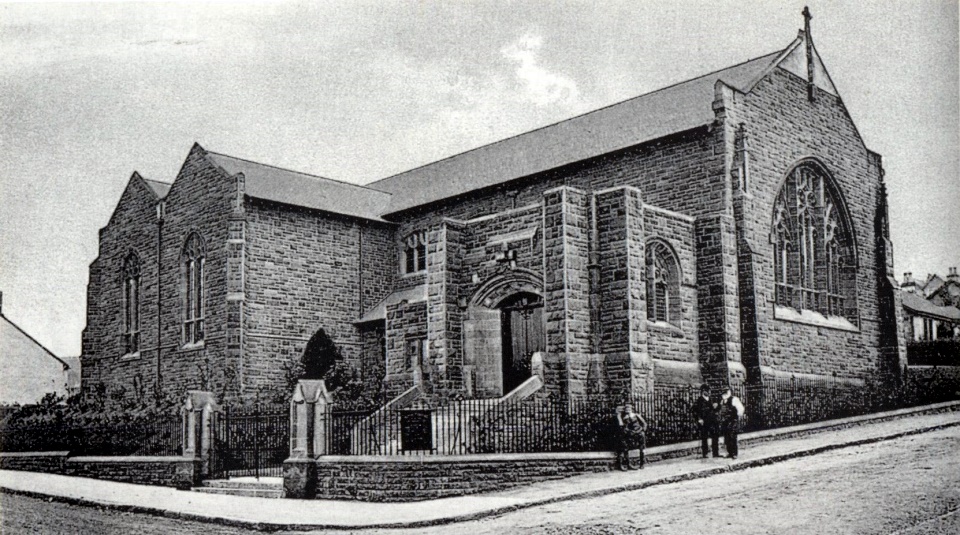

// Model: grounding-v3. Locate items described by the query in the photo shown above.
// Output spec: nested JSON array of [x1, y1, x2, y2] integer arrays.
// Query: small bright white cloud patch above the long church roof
[[500, 34, 580, 106]]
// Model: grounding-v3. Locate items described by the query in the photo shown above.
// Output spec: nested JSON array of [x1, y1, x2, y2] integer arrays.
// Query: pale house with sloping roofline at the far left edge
[[0, 293, 79, 405]]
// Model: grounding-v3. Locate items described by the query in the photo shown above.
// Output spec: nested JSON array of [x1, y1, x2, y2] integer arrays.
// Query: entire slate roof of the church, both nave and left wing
[[182, 31, 837, 221]]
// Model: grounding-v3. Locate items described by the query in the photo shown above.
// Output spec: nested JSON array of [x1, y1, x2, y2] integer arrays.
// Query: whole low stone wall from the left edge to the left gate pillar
[[0, 451, 202, 489]]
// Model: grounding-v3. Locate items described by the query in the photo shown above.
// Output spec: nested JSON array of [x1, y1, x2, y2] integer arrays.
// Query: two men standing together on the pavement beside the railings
[[693, 385, 744, 459]]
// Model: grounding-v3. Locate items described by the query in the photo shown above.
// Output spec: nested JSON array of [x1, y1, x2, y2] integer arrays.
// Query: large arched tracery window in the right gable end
[[772, 162, 856, 321]]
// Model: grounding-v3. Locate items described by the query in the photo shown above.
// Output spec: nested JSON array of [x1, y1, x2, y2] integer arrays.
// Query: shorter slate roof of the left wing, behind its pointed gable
[[206, 151, 390, 221]]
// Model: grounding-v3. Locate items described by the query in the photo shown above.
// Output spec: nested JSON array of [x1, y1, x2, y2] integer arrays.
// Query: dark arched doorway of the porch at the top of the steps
[[497, 292, 546, 394]]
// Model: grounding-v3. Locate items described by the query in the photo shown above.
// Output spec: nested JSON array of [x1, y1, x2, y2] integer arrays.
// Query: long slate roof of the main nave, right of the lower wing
[[368, 49, 796, 212]]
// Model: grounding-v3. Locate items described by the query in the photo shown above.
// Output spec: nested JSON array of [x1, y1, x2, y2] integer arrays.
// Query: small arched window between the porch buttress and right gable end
[[646, 240, 682, 327]]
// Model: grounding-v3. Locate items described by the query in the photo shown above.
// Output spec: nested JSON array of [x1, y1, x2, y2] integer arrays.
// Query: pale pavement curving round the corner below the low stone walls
[[0, 402, 960, 531]]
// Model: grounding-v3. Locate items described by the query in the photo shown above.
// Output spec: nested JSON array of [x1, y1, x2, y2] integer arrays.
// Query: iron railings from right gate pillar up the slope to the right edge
[[321, 375, 960, 455]]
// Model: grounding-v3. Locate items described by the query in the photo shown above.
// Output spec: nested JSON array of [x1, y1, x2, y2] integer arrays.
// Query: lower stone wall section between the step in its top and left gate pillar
[[64, 457, 201, 489]]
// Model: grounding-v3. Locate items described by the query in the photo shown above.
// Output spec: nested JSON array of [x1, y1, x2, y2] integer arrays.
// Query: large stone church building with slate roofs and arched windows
[[83, 22, 906, 418]]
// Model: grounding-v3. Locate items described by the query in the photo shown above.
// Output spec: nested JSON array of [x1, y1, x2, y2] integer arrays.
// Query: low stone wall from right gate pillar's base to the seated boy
[[284, 452, 615, 502]]
